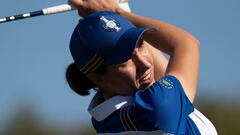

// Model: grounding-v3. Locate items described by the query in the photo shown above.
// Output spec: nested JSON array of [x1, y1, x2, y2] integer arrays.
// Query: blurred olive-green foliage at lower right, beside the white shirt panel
[[197, 101, 240, 135]]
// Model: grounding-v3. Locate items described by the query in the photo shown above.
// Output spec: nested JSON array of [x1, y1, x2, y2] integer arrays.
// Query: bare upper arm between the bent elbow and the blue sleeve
[[166, 39, 200, 102]]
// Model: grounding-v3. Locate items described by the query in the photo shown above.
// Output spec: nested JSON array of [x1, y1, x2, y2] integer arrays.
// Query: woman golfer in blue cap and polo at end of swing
[[66, 0, 217, 135]]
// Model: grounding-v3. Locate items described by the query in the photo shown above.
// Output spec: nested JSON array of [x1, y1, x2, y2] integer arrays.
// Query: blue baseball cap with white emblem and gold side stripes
[[70, 11, 150, 74]]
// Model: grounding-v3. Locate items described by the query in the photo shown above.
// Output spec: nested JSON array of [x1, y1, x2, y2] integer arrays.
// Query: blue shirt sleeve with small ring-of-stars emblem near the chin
[[129, 75, 194, 134]]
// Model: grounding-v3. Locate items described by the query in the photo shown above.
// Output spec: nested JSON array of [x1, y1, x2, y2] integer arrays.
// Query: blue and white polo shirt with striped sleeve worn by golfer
[[89, 75, 216, 135]]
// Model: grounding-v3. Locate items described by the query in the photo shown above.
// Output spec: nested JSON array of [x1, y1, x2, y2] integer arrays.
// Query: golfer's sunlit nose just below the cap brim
[[133, 48, 151, 72]]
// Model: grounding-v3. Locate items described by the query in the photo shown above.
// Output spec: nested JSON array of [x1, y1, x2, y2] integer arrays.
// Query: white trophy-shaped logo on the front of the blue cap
[[100, 16, 122, 32]]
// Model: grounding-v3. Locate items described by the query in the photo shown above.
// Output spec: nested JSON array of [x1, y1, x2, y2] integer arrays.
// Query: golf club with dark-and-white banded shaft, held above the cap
[[0, 0, 130, 23]]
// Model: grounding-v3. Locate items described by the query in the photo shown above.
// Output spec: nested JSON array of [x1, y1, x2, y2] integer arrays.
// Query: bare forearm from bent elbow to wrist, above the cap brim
[[117, 9, 198, 54]]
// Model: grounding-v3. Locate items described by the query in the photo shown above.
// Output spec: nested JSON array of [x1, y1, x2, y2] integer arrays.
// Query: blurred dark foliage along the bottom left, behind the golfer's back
[[0, 105, 96, 135]]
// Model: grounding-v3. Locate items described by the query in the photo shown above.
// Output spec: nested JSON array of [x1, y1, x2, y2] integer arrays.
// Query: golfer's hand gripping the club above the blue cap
[[68, 0, 119, 17]]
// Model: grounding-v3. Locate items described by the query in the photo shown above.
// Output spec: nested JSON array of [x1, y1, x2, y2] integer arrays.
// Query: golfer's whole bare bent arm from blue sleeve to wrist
[[117, 8, 200, 102]]
